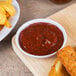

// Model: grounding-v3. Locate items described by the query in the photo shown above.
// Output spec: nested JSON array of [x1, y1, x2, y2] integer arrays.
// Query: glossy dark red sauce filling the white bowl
[[19, 22, 64, 56]]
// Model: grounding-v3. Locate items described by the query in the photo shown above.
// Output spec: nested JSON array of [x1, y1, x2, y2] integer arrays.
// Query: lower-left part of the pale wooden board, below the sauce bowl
[[12, 36, 56, 76]]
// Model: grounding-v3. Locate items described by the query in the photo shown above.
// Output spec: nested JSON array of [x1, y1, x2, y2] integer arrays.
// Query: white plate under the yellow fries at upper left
[[0, 0, 20, 41]]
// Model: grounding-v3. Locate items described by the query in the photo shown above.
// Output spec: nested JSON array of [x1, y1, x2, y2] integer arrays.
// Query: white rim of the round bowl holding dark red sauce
[[15, 19, 67, 58]]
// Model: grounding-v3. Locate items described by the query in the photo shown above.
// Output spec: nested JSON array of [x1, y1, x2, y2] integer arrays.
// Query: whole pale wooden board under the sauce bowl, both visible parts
[[12, 4, 76, 76]]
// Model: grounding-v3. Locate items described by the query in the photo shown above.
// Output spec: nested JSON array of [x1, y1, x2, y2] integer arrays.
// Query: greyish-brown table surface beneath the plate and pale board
[[0, 0, 76, 76]]
